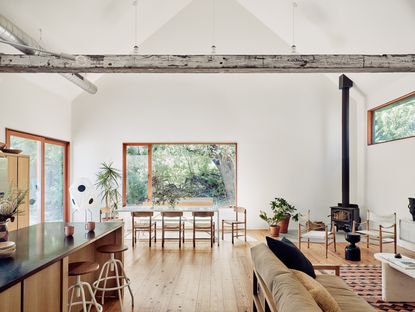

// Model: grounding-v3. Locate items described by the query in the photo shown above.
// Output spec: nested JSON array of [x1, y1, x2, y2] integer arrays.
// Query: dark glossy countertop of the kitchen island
[[0, 222, 123, 292]]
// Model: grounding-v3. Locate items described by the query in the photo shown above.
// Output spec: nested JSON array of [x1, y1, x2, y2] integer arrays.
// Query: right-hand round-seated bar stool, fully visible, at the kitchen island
[[92, 245, 134, 311]]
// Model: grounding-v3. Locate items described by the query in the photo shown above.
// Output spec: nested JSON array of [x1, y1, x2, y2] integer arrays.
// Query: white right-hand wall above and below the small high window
[[366, 75, 415, 250]]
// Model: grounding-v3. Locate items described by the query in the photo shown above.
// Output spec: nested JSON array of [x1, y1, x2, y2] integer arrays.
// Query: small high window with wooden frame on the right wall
[[368, 92, 415, 144]]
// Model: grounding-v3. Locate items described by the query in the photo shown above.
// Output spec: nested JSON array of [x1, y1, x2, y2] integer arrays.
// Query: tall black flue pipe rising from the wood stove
[[339, 75, 353, 207]]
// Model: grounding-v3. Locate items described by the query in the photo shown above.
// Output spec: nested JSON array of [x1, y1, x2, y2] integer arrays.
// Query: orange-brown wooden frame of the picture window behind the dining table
[[122, 142, 238, 207]]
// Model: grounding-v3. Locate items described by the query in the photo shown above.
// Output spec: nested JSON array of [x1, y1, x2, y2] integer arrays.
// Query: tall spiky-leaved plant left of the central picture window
[[95, 162, 121, 220]]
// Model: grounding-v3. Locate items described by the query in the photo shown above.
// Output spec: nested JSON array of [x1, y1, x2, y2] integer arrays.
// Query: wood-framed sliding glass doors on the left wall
[[6, 129, 69, 225]]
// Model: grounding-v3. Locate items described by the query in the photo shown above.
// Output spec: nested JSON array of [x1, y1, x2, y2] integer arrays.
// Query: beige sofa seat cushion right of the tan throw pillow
[[316, 274, 376, 312]]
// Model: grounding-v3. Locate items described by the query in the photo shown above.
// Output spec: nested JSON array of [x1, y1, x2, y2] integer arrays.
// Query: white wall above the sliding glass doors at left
[[0, 74, 71, 141]]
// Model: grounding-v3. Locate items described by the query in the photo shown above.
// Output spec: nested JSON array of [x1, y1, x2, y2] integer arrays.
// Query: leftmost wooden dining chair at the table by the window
[[131, 211, 157, 247]]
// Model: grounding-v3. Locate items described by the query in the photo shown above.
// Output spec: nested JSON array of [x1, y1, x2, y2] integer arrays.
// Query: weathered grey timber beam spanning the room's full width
[[0, 54, 415, 73]]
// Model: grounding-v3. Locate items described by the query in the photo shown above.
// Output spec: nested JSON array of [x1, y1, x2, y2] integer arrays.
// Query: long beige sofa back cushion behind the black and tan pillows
[[251, 244, 321, 312]]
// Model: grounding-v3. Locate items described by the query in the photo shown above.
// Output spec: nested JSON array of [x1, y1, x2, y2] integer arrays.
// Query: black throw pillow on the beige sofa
[[266, 236, 316, 278]]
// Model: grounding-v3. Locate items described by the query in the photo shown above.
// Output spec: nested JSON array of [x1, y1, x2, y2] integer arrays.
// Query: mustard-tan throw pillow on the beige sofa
[[291, 270, 341, 312]]
